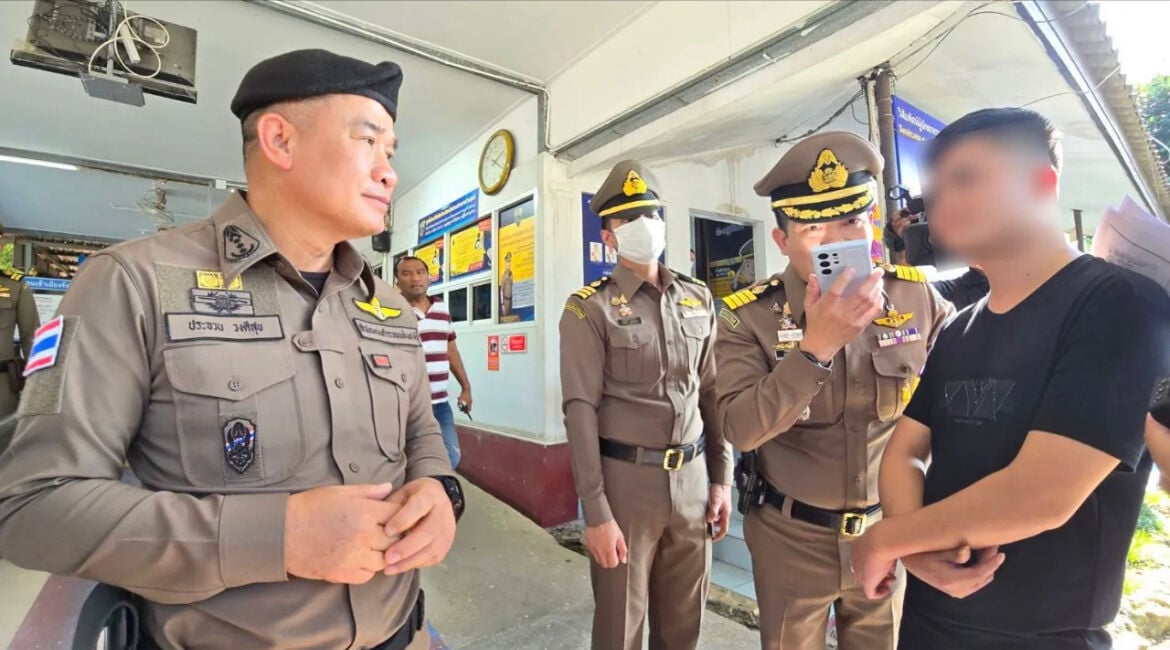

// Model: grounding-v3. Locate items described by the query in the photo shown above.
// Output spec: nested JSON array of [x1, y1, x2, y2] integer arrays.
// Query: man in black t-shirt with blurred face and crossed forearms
[[853, 109, 1170, 650]]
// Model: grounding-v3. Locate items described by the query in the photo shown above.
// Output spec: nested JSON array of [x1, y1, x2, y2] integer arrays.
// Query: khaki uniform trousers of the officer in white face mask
[[590, 456, 711, 650]]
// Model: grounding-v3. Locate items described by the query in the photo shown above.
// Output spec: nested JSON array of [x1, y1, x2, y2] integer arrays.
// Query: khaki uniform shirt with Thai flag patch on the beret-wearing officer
[[0, 195, 452, 649]]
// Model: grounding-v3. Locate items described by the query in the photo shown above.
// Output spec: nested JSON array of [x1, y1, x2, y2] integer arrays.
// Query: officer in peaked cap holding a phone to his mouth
[[715, 132, 952, 650]]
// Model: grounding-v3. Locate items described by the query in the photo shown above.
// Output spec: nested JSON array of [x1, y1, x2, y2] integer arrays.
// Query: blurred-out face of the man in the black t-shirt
[[927, 136, 1057, 263]]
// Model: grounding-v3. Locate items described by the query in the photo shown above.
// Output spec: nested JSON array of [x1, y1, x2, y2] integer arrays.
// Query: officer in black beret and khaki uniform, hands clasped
[[0, 50, 462, 650]]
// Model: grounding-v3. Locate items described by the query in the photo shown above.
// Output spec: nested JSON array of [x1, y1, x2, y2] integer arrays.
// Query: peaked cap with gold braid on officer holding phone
[[755, 131, 882, 223]]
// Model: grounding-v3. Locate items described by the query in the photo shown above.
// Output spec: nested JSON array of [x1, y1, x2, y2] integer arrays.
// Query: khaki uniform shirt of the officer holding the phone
[[715, 267, 954, 510]]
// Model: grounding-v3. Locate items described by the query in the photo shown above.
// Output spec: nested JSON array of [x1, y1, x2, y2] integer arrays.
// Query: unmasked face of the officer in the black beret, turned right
[[260, 95, 398, 241]]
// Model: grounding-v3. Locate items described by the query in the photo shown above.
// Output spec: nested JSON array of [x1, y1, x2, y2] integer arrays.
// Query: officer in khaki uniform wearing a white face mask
[[560, 160, 731, 650]]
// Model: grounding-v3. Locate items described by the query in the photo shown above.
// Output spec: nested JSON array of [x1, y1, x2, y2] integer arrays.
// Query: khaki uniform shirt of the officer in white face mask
[[560, 265, 731, 526]]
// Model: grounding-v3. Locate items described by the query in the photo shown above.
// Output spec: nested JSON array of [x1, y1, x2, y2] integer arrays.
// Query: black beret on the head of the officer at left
[[232, 49, 402, 122]]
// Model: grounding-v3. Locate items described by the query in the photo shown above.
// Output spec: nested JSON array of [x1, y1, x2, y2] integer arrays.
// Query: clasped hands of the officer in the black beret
[[284, 478, 455, 585]]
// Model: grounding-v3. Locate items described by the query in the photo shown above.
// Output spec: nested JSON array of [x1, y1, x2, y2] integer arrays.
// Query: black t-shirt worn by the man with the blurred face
[[900, 256, 1170, 650]]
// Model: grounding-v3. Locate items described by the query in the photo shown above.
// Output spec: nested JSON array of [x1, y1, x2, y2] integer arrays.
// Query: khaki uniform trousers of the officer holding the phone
[[743, 502, 906, 650]]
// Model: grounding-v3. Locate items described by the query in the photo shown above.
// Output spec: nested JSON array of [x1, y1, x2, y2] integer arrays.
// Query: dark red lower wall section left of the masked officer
[[456, 426, 577, 527]]
